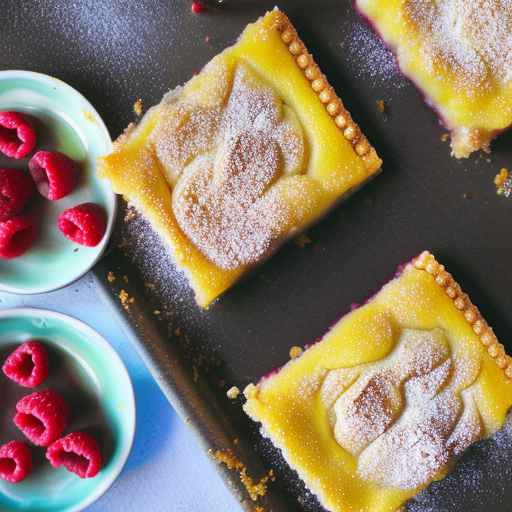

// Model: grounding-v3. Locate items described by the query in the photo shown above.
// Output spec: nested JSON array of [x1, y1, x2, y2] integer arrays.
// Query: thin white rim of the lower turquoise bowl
[[0, 307, 137, 512]]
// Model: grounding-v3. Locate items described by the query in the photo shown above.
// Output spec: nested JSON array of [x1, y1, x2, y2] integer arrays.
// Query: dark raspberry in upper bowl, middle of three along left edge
[[0, 169, 34, 221]]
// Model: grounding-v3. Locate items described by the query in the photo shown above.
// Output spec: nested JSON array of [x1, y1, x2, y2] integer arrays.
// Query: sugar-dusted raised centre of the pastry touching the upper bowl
[[153, 61, 305, 269]]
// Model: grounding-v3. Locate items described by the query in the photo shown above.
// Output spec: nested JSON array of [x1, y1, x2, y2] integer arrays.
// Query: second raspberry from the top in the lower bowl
[[14, 389, 69, 446]]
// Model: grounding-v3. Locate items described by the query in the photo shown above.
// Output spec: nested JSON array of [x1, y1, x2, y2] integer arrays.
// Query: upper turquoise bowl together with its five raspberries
[[0, 71, 116, 294]]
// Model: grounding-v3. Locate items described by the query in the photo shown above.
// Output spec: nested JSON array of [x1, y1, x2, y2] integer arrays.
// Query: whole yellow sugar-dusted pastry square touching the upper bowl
[[99, 9, 381, 307]]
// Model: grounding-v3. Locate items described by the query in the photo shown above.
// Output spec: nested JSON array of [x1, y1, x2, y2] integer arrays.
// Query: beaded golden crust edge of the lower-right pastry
[[412, 251, 512, 380]]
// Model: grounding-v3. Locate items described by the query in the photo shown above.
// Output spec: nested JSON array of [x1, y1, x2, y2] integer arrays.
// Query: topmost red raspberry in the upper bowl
[[0, 112, 36, 160]]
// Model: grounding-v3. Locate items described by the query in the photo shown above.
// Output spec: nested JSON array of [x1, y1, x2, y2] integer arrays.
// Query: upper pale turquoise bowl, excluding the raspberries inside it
[[0, 71, 116, 294]]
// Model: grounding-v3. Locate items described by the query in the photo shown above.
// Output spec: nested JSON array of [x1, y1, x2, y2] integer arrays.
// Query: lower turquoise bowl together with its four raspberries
[[0, 308, 135, 512]]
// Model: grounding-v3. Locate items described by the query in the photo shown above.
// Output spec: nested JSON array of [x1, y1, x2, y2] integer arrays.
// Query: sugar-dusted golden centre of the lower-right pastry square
[[321, 329, 482, 489]]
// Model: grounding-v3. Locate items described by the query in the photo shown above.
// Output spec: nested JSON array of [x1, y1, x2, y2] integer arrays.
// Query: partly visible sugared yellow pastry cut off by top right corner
[[356, 0, 512, 158]]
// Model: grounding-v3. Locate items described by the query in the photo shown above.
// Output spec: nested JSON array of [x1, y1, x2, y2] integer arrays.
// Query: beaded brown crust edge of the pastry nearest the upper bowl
[[275, 11, 382, 173]]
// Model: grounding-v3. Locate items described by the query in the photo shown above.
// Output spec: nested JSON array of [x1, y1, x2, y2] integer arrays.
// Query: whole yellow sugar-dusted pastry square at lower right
[[244, 252, 512, 512]]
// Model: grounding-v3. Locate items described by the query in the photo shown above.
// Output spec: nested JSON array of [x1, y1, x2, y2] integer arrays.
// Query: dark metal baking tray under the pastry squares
[[0, 0, 512, 512]]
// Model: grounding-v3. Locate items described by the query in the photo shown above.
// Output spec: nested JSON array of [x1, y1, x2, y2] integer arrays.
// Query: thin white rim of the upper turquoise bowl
[[0, 69, 118, 295]]
